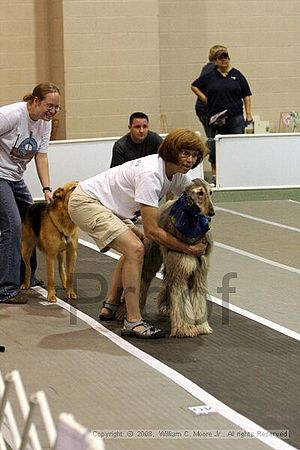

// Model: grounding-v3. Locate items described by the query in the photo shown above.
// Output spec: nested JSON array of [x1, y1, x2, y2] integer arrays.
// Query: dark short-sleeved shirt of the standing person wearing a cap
[[192, 67, 251, 116]]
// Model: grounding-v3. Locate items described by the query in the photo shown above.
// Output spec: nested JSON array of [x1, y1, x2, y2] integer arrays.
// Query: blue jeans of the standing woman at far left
[[0, 178, 36, 302]]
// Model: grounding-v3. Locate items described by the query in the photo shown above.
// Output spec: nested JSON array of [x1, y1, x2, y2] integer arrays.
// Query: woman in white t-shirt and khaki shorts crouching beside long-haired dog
[[69, 128, 207, 339]]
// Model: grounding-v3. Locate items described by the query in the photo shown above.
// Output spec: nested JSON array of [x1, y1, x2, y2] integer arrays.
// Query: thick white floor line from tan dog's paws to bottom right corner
[[33, 286, 297, 450]]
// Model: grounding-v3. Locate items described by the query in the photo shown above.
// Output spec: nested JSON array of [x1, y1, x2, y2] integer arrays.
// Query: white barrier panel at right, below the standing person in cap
[[216, 133, 300, 189]]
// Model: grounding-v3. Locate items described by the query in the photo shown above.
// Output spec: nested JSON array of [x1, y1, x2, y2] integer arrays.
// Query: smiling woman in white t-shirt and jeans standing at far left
[[0, 82, 60, 304]]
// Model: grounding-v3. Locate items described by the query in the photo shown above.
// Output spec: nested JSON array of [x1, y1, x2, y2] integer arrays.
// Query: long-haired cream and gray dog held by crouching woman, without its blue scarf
[[140, 179, 215, 337]]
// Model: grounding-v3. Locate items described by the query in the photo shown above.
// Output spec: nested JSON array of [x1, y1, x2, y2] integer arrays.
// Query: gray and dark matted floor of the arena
[[0, 200, 300, 449]]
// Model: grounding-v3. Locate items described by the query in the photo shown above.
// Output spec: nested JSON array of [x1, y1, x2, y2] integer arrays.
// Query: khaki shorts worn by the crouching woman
[[68, 186, 134, 250]]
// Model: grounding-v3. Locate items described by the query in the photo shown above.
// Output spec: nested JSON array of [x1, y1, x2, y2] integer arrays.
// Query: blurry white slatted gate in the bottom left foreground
[[0, 370, 104, 450]]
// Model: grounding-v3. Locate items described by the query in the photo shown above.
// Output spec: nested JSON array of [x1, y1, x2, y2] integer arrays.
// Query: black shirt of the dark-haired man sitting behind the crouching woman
[[110, 131, 162, 167]]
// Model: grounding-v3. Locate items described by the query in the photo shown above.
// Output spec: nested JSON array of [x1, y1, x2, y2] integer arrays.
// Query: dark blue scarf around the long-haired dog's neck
[[170, 192, 210, 239]]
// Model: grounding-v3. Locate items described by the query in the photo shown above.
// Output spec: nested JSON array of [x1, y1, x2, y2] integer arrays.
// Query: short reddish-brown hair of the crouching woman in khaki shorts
[[158, 128, 208, 169]]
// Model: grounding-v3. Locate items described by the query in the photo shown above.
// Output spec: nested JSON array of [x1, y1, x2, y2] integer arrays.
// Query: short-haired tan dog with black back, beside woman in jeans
[[21, 181, 79, 303]]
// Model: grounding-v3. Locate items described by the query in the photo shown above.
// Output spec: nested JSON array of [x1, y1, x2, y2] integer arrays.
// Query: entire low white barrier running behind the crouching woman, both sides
[[24, 133, 300, 199]]
